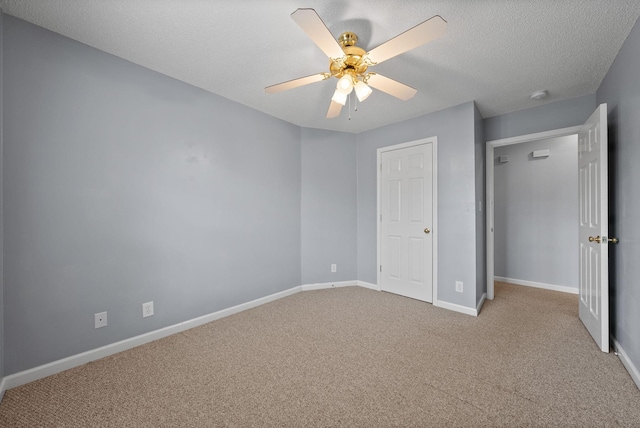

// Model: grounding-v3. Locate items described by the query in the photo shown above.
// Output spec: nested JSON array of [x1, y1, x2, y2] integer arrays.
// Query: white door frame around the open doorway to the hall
[[485, 126, 582, 300]]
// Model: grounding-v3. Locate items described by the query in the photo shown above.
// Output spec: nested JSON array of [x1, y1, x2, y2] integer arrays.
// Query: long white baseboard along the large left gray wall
[[2, 286, 302, 391]]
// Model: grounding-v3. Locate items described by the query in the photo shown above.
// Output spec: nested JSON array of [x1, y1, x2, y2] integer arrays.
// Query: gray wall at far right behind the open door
[[596, 16, 640, 378]]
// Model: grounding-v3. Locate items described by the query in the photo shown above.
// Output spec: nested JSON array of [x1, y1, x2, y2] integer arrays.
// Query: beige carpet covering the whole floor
[[0, 284, 640, 427]]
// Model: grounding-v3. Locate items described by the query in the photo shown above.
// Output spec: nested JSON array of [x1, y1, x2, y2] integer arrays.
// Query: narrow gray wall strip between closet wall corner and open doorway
[[473, 103, 487, 304]]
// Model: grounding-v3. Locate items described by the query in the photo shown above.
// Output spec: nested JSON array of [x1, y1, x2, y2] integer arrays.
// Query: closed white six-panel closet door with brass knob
[[379, 143, 434, 302]]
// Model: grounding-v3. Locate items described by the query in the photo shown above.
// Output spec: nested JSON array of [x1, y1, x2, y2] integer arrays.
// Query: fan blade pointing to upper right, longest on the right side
[[369, 15, 447, 64]]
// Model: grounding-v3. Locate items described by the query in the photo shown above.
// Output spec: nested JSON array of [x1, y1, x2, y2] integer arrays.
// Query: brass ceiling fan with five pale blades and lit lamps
[[265, 9, 447, 118]]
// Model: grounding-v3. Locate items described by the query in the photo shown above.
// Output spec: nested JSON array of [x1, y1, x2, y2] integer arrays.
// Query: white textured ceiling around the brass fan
[[0, 0, 640, 132]]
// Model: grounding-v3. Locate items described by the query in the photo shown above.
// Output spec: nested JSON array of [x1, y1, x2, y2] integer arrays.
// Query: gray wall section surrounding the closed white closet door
[[357, 102, 476, 308]]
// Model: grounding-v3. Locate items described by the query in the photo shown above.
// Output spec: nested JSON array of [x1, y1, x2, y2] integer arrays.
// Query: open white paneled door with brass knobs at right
[[578, 104, 609, 352]]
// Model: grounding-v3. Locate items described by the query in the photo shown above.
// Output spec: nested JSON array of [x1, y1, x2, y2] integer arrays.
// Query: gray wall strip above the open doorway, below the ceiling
[[484, 94, 596, 141]]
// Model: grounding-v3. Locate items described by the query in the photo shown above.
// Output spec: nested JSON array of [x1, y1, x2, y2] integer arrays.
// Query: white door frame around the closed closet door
[[376, 137, 438, 306]]
